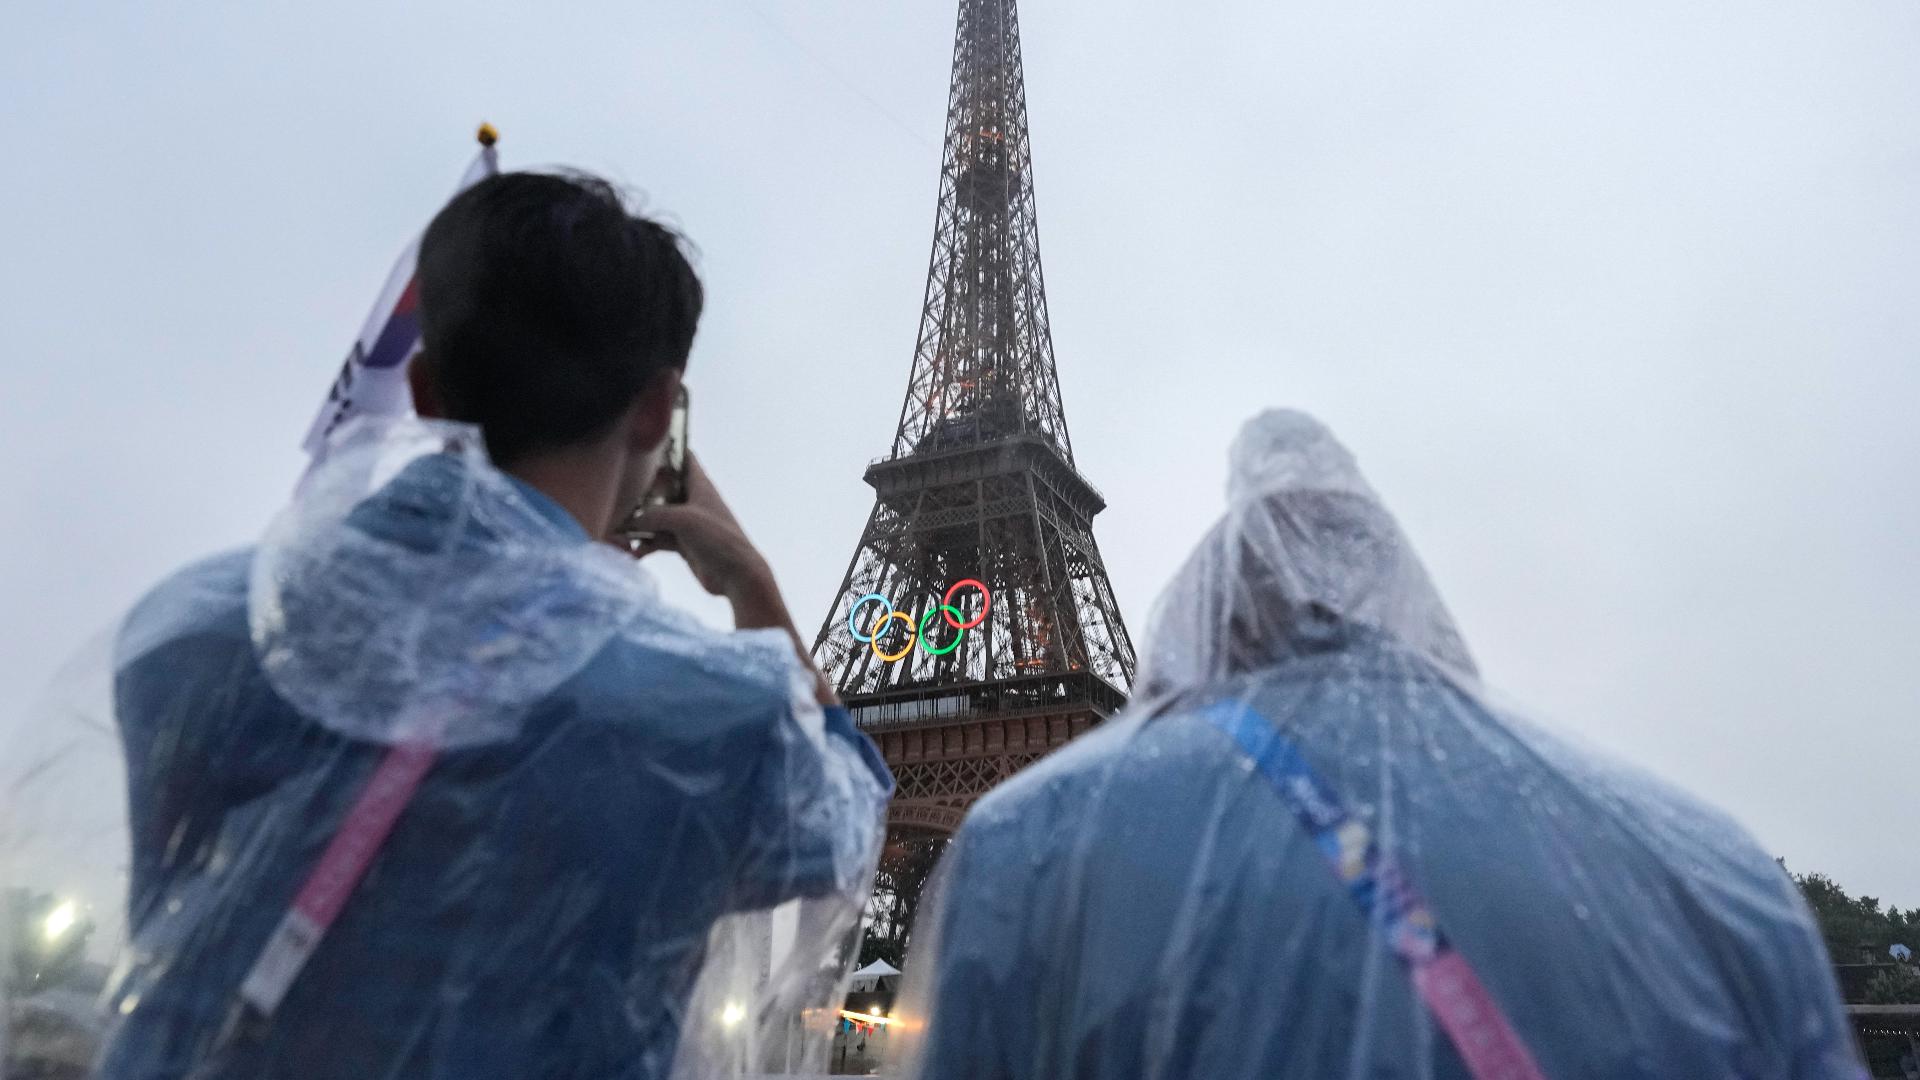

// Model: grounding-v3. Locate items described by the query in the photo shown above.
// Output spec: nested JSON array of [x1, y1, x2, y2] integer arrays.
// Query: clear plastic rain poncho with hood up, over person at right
[[895, 411, 1864, 1080]]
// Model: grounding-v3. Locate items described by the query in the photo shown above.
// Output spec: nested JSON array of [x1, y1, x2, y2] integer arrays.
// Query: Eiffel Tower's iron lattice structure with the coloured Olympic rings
[[814, 0, 1135, 832]]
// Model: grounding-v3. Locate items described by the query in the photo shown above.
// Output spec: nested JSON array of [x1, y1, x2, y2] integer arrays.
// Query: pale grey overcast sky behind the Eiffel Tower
[[0, 0, 1920, 907]]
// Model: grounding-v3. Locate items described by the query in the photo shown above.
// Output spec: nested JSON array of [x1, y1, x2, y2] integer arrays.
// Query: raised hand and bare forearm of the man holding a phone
[[622, 454, 839, 705]]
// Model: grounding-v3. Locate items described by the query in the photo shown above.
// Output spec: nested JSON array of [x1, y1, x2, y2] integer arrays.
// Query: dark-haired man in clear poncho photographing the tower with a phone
[[8, 173, 891, 1080]]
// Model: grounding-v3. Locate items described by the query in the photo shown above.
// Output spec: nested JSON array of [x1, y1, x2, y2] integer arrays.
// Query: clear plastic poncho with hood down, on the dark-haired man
[[0, 419, 891, 1080]]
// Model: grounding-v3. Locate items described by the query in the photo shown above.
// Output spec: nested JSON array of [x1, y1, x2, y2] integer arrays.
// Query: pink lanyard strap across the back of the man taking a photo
[[240, 742, 440, 1017]]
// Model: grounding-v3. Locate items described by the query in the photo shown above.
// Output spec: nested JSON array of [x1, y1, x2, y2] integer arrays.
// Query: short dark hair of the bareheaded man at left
[[419, 173, 703, 465]]
